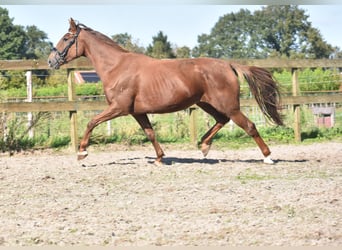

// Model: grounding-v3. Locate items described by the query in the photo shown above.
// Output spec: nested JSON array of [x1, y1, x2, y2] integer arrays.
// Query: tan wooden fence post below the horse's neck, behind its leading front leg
[[67, 69, 78, 152]]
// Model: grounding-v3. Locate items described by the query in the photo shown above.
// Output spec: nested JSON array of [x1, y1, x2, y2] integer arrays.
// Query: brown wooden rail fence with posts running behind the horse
[[0, 58, 342, 150]]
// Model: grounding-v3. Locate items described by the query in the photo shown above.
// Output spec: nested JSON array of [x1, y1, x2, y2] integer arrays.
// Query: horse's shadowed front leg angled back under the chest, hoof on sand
[[133, 114, 164, 165]]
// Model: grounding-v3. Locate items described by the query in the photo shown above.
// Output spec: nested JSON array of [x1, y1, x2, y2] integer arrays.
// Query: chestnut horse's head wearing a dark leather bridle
[[48, 18, 84, 69]]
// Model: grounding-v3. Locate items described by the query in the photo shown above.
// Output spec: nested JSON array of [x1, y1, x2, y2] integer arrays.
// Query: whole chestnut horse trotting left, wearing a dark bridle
[[48, 18, 283, 164]]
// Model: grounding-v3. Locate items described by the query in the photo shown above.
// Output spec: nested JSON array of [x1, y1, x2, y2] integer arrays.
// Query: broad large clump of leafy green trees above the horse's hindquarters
[[193, 5, 334, 58]]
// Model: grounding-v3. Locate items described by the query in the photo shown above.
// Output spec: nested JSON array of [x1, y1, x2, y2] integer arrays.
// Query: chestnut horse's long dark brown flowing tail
[[231, 64, 284, 125]]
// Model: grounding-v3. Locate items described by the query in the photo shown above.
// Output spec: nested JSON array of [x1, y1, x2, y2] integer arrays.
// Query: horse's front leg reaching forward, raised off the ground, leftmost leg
[[77, 105, 126, 160]]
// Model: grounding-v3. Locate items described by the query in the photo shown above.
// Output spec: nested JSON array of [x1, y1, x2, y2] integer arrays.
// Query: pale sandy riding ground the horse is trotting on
[[0, 142, 342, 246]]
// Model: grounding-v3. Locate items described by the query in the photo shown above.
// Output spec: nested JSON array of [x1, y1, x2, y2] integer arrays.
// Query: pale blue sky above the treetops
[[1, 4, 342, 49]]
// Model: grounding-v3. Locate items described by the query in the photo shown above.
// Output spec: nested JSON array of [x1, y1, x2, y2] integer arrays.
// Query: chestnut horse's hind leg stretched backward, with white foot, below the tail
[[230, 110, 273, 164]]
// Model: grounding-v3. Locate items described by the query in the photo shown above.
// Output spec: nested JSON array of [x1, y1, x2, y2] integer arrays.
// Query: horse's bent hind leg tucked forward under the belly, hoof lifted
[[197, 103, 229, 156]]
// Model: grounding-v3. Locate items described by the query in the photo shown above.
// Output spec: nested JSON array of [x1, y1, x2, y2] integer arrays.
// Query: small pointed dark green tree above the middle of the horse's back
[[146, 31, 176, 58]]
